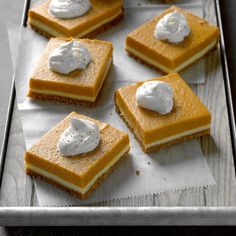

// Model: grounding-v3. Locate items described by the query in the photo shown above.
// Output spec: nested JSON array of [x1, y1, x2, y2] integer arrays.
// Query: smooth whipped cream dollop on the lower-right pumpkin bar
[[136, 81, 174, 115]]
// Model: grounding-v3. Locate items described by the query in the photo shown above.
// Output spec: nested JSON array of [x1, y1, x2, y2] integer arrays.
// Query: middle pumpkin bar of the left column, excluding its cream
[[28, 38, 113, 105]]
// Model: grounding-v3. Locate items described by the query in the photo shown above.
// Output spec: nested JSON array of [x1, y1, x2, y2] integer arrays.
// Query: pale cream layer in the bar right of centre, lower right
[[116, 97, 211, 149]]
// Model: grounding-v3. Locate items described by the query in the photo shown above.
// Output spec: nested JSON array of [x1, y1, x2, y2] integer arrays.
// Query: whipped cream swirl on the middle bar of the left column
[[48, 40, 91, 74]]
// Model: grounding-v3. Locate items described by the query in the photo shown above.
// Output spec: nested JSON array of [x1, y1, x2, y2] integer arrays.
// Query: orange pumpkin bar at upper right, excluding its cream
[[126, 6, 219, 73]]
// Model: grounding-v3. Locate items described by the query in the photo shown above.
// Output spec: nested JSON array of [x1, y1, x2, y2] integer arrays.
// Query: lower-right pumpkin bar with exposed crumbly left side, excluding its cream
[[115, 73, 211, 152]]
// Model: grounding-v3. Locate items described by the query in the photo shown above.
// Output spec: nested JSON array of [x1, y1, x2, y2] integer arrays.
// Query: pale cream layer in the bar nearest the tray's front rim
[[25, 145, 130, 195]]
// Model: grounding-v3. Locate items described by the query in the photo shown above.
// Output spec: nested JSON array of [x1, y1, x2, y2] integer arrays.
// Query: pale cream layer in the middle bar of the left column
[[30, 58, 112, 102]]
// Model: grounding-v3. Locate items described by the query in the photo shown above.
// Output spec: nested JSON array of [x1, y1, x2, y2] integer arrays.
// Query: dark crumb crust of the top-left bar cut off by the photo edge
[[29, 8, 124, 39]]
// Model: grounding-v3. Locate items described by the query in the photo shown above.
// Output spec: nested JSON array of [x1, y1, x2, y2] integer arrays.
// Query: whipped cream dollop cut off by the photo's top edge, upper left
[[49, 0, 91, 19]]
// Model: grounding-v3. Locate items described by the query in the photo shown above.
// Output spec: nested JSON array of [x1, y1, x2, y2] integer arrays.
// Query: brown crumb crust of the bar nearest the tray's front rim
[[26, 150, 129, 200]]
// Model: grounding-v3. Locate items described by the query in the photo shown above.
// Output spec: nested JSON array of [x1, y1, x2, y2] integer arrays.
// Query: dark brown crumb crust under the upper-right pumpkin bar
[[125, 40, 219, 75]]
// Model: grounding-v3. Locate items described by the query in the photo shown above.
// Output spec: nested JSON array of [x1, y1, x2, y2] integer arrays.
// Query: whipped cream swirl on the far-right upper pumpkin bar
[[154, 11, 190, 43]]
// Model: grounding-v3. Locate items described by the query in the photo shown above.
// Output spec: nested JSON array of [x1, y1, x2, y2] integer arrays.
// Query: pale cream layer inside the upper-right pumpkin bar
[[126, 40, 218, 73]]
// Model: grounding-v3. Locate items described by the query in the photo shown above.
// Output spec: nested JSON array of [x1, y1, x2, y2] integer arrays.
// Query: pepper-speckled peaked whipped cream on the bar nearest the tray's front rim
[[57, 117, 100, 156]]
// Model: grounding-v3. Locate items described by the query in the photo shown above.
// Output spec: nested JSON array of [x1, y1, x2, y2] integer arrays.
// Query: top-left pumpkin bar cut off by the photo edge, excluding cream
[[28, 0, 124, 38]]
